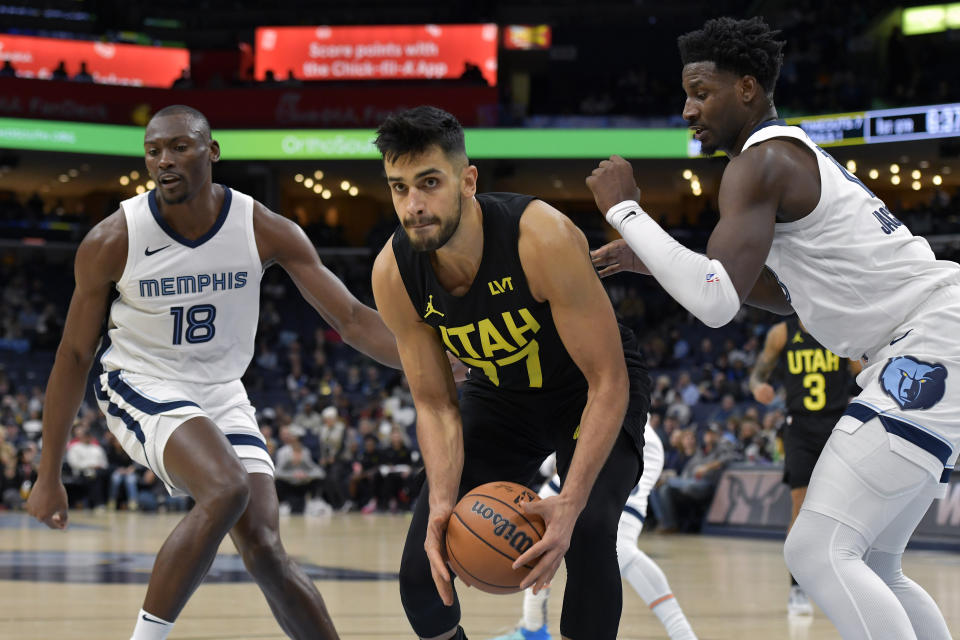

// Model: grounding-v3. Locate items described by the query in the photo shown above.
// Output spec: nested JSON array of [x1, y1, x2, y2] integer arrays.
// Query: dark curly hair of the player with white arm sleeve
[[677, 16, 786, 95]]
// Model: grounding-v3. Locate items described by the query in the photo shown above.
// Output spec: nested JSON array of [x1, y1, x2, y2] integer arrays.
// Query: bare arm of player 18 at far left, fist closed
[[27, 212, 127, 529]]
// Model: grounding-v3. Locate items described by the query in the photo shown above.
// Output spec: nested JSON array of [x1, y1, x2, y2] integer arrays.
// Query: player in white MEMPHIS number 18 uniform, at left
[[28, 105, 399, 640]]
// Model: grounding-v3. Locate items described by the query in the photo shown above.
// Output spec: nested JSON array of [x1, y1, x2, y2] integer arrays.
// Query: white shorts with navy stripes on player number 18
[[94, 370, 273, 495]]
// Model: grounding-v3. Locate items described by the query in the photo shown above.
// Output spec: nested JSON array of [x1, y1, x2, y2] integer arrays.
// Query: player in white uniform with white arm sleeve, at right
[[587, 18, 960, 640]]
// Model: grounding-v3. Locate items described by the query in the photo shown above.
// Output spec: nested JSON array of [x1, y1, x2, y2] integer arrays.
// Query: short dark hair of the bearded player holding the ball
[[374, 105, 467, 162]]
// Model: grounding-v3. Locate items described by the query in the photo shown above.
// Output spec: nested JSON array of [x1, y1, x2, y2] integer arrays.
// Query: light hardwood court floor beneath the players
[[0, 512, 960, 640]]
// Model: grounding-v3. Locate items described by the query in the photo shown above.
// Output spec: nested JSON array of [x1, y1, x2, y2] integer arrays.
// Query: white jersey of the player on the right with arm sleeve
[[743, 124, 960, 359]]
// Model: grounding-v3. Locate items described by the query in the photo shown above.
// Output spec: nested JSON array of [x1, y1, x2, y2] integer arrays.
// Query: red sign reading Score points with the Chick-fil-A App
[[254, 24, 497, 86]]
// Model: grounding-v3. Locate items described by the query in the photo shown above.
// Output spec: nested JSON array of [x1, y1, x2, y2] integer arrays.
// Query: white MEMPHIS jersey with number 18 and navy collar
[[100, 187, 263, 383]]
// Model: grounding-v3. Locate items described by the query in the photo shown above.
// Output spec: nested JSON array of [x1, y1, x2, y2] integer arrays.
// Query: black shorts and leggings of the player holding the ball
[[400, 372, 649, 640]]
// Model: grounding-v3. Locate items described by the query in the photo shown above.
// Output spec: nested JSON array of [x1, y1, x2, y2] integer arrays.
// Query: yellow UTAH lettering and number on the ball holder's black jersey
[[431, 308, 543, 388]]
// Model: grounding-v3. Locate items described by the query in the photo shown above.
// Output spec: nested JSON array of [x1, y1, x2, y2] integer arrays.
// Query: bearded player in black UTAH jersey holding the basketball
[[373, 107, 650, 640]]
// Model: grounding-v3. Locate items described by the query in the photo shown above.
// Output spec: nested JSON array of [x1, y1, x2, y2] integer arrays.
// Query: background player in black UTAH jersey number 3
[[750, 316, 860, 615]]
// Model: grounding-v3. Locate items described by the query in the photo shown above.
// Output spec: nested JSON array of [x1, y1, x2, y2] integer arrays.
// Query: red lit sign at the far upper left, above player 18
[[0, 34, 190, 88]]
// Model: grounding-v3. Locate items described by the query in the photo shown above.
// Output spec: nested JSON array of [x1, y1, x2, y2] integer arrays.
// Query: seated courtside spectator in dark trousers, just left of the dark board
[[655, 429, 737, 532]]
